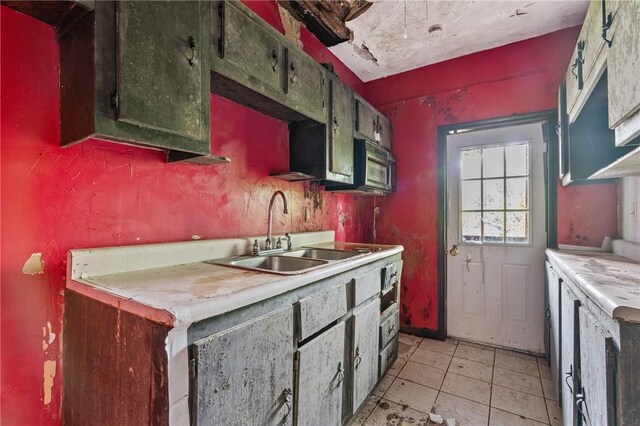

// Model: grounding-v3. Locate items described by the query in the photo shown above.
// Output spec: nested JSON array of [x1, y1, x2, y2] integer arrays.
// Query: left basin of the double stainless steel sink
[[207, 256, 329, 275]]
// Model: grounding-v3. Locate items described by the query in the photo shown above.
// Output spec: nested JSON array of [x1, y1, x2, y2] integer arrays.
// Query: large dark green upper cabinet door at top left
[[116, 1, 209, 139]]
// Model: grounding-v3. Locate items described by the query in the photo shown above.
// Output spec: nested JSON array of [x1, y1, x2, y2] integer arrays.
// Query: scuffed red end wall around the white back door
[[364, 28, 616, 330]]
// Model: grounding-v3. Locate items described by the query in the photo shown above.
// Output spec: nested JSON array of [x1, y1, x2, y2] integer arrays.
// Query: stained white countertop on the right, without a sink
[[546, 249, 640, 322]]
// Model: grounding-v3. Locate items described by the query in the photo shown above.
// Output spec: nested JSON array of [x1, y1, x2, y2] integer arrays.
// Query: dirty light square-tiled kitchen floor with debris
[[351, 334, 562, 426]]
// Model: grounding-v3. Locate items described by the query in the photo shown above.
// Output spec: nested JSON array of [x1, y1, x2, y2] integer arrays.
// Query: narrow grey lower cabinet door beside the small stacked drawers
[[351, 299, 380, 412]]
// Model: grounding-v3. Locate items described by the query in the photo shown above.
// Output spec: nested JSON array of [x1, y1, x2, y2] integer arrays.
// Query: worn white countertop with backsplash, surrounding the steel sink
[[67, 233, 402, 326]]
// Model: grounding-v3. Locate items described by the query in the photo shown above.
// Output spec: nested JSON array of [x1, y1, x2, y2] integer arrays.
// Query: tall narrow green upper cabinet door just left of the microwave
[[327, 77, 353, 183]]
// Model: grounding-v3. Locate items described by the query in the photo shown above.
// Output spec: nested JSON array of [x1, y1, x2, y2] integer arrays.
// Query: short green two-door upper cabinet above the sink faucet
[[211, 0, 326, 123]]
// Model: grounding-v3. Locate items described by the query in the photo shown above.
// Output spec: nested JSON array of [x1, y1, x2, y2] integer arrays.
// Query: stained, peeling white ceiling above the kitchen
[[331, 0, 589, 81]]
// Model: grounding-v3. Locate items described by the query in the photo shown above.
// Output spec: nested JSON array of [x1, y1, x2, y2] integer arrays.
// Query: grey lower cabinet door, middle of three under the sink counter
[[296, 322, 345, 426]]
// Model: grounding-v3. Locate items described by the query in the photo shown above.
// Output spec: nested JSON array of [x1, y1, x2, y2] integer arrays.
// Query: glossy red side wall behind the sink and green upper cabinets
[[0, 2, 372, 425]]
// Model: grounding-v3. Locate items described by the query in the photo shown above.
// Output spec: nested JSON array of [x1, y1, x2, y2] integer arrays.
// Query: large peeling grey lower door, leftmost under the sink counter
[[191, 306, 293, 425]]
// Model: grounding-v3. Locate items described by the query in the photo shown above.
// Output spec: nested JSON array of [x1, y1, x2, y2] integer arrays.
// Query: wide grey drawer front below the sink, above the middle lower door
[[298, 284, 347, 340]]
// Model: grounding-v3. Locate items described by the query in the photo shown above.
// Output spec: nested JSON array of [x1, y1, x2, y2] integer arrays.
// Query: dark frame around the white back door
[[432, 110, 559, 340]]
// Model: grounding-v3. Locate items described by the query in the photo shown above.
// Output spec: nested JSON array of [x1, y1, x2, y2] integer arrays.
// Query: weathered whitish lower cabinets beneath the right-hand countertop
[[547, 255, 640, 426]]
